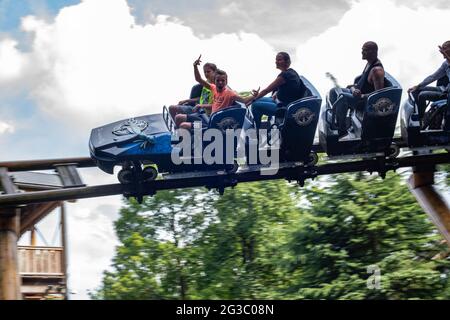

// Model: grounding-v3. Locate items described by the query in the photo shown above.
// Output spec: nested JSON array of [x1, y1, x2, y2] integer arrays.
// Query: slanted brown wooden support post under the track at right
[[409, 166, 450, 246]]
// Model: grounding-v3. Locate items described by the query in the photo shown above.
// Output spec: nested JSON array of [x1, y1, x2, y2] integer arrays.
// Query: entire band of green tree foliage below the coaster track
[[91, 174, 450, 299]]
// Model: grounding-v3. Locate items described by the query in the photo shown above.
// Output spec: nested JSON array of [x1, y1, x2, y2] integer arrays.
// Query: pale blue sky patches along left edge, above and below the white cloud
[[0, 0, 85, 160]]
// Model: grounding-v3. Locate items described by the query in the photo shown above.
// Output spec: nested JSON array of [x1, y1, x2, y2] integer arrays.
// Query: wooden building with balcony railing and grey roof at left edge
[[0, 166, 77, 300]]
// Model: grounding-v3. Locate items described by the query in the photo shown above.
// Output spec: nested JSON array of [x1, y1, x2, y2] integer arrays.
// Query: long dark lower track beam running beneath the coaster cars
[[0, 153, 450, 208]]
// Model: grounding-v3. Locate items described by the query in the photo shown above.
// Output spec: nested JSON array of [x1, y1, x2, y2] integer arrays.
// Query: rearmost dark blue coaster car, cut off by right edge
[[401, 77, 450, 150]]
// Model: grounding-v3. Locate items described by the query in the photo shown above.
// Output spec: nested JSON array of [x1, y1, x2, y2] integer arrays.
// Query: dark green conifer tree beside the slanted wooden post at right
[[290, 174, 449, 299]]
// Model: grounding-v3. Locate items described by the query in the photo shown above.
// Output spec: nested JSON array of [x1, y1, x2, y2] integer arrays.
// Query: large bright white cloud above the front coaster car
[[11, 0, 274, 130]]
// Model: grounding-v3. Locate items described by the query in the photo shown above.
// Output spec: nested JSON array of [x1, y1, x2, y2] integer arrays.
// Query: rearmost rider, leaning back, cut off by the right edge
[[408, 41, 450, 121]]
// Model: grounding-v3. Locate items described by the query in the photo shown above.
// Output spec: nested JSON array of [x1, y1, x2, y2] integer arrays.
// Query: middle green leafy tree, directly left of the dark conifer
[[192, 181, 300, 299]]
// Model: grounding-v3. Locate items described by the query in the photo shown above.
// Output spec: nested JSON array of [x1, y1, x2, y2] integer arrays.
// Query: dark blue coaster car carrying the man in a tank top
[[319, 73, 402, 158]]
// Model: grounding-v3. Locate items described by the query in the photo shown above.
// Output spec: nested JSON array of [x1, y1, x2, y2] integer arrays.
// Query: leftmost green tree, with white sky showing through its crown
[[91, 189, 214, 299]]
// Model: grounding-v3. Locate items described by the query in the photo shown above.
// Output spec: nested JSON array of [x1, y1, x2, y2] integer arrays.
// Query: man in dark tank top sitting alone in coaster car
[[329, 41, 388, 138]]
